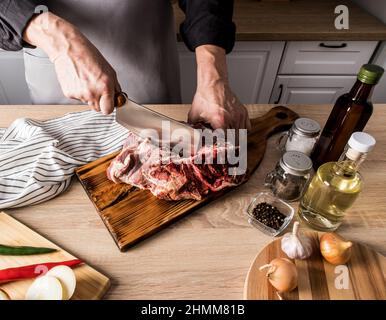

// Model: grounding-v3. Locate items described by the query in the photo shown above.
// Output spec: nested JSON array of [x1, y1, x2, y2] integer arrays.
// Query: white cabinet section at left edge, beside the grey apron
[[0, 50, 31, 104]]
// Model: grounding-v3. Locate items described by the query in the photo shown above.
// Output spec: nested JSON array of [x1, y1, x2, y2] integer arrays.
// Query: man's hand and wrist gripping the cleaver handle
[[23, 12, 121, 114]]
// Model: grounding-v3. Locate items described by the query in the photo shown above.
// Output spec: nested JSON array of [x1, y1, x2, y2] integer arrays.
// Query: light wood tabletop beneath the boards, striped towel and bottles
[[0, 105, 386, 299]]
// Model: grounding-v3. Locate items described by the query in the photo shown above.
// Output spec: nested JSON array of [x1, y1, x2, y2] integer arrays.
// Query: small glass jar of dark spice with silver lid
[[265, 151, 312, 201]]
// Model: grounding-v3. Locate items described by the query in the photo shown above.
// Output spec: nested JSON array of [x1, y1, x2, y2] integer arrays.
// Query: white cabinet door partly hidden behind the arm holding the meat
[[178, 41, 284, 103]]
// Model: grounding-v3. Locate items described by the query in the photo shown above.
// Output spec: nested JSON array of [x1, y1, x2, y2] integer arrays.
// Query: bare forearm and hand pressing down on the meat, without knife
[[189, 45, 250, 129]]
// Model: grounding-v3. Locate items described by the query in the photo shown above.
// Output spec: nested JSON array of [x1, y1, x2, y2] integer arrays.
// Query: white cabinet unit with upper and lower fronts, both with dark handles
[[270, 41, 378, 104]]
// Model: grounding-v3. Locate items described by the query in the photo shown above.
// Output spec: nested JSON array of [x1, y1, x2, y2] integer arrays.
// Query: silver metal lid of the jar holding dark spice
[[280, 151, 312, 176]]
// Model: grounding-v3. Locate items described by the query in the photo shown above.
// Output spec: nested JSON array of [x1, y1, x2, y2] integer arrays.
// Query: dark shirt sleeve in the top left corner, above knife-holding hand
[[0, 0, 44, 51]]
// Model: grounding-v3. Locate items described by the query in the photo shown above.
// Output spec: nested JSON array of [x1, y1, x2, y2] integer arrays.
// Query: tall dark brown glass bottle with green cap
[[311, 64, 384, 170]]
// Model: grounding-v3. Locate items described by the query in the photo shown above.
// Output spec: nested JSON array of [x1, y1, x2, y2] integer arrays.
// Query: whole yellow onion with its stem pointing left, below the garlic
[[259, 258, 298, 292]]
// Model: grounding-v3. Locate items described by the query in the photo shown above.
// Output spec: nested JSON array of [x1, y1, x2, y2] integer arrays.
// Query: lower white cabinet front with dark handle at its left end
[[270, 75, 356, 104]]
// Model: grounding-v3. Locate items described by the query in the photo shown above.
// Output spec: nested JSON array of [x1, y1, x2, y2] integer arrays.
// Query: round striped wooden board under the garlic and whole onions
[[244, 232, 386, 300]]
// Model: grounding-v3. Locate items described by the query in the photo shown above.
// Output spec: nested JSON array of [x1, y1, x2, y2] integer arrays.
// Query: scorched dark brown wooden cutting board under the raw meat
[[77, 107, 298, 251]]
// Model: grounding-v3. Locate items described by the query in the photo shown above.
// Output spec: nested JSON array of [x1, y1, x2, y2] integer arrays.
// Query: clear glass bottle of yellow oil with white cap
[[298, 132, 375, 231]]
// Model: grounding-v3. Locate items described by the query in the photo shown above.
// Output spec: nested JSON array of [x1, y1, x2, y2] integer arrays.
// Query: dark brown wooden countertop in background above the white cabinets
[[174, 0, 386, 41]]
